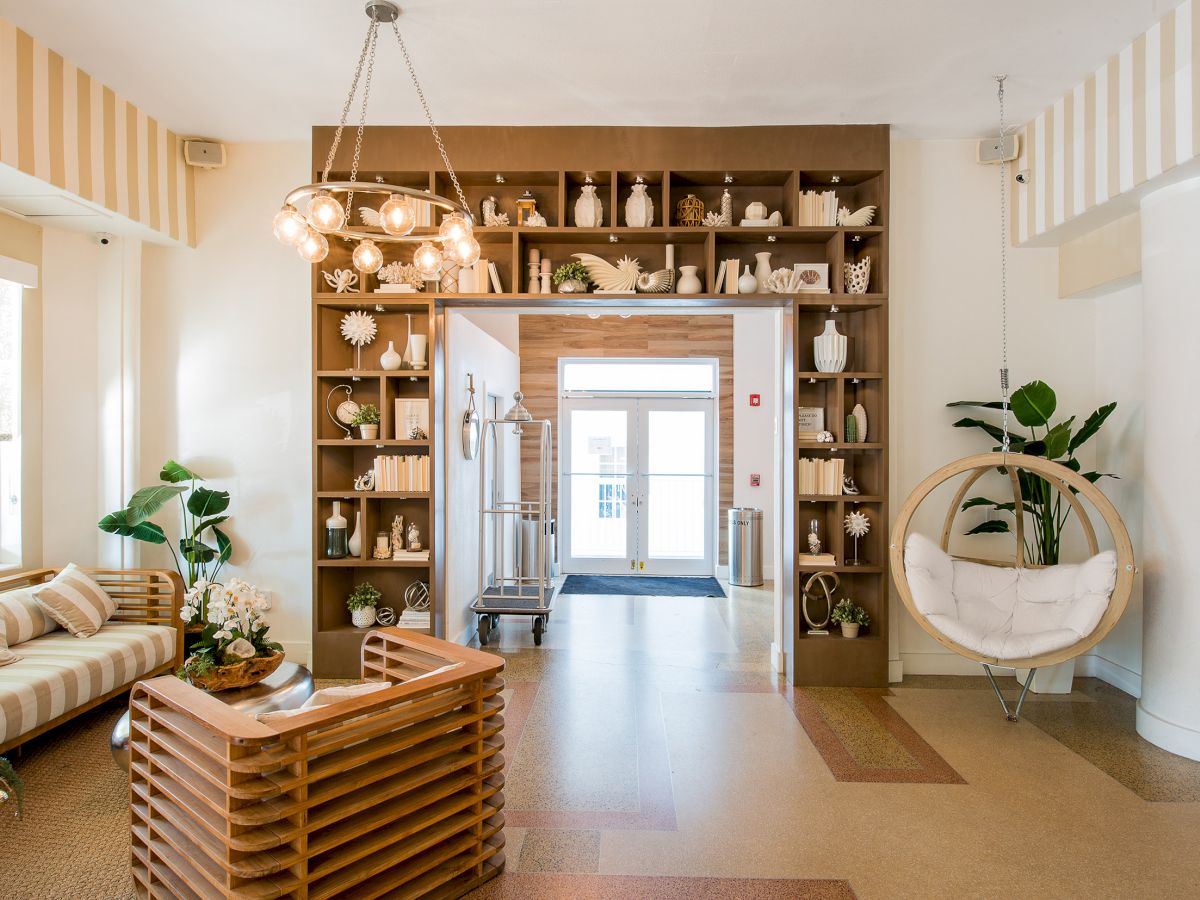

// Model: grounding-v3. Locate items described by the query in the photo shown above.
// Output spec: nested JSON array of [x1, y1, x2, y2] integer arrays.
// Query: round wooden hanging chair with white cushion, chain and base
[[889, 77, 1138, 721]]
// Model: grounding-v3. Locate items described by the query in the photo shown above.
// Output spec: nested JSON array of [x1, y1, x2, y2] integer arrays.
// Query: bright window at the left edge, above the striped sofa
[[0, 280, 22, 566]]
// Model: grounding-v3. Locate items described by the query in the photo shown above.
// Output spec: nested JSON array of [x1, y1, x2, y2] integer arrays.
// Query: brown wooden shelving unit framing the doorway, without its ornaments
[[312, 126, 889, 685]]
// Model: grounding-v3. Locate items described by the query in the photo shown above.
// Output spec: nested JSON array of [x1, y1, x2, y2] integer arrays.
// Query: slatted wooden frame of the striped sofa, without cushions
[[0, 569, 184, 754]]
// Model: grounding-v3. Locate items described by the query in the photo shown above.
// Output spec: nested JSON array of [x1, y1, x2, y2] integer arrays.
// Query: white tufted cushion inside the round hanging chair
[[905, 534, 1117, 659]]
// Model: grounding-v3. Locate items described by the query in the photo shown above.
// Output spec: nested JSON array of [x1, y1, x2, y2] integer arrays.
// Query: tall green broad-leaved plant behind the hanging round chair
[[947, 382, 1117, 565]]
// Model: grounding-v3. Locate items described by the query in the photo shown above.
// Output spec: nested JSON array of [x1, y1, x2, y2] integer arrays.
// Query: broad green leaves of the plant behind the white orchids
[[100, 460, 233, 588]]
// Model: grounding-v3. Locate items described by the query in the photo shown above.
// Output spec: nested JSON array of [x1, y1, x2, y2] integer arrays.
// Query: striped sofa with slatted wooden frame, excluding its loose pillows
[[0, 569, 184, 754]]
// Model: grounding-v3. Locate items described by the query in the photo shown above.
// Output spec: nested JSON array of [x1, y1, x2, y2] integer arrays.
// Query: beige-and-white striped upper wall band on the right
[[1013, 0, 1200, 244]]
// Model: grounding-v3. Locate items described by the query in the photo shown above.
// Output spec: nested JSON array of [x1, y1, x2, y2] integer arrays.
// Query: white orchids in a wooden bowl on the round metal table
[[179, 578, 283, 691]]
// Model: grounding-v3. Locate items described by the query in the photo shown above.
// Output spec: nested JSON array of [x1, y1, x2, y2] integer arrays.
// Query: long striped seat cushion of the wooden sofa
[[0, 624, 175, 744]]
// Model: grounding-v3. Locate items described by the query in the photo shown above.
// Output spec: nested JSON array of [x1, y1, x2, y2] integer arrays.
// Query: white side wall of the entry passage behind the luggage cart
[[442, 312, 521, 643]]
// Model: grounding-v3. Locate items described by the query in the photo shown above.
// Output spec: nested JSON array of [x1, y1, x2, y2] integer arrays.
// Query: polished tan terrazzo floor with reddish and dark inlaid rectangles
[[465, 580, 1200, 898]]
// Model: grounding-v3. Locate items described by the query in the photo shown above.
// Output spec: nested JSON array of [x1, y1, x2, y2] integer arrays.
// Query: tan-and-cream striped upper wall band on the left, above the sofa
[[0, 18, 196, 246]]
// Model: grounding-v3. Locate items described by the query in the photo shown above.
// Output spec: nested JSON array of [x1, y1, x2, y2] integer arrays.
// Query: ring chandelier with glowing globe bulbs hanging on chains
[[272, 0, 479, 278]]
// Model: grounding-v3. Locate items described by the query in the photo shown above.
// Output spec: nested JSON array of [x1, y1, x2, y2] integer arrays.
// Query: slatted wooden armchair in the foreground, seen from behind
[[130, 628, 504, 900]]
